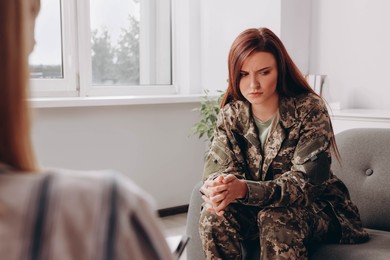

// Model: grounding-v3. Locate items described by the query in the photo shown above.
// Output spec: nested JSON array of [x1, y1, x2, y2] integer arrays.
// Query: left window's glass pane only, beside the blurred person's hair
[[29, 0, 64, 79]]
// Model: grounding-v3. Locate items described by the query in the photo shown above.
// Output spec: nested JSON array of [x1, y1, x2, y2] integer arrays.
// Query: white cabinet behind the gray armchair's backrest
[[329, 109, 390, 134]]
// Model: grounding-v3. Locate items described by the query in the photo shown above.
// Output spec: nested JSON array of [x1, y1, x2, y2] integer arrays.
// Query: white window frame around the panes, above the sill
[[30, 0, 179, 98]]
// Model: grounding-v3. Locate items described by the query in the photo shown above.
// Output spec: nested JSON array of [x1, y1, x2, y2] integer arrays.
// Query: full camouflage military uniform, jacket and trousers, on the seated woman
[[199, 94, 368, 259]]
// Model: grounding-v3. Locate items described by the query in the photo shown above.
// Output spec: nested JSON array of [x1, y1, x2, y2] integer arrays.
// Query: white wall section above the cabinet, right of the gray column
[[310, 0, 390, 109]]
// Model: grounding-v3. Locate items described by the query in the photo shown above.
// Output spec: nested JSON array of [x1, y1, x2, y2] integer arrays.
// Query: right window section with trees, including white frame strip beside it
[[90, 0, 171, 86]]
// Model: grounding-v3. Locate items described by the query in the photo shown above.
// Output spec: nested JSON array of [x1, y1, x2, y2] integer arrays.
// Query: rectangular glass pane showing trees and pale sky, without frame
[[91, 0, 140, 85]]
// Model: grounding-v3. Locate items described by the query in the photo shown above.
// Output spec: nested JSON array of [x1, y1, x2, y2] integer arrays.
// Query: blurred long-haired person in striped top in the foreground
[[0, 0, 173, 260]]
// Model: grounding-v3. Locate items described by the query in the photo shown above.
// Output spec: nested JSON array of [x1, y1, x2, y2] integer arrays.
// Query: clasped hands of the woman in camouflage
[[200, 174, 248, 216]]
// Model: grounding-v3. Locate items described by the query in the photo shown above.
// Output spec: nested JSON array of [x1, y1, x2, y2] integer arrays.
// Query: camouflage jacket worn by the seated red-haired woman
[[203, 94, 368, 243]]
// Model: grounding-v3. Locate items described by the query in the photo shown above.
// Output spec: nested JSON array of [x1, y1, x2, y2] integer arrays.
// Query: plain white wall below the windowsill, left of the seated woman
[[33, 103, 205, 209]]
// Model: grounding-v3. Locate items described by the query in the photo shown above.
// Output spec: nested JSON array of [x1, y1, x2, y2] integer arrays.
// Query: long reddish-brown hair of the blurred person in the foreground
[[0, 0, 39, 171]]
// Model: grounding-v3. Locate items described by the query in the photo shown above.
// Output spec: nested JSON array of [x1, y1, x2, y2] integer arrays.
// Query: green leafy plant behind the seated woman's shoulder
[[191, 90, 224, 143]]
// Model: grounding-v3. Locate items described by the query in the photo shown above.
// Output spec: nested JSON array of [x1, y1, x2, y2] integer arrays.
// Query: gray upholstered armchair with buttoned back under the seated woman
[[186, 128, 390, 260]]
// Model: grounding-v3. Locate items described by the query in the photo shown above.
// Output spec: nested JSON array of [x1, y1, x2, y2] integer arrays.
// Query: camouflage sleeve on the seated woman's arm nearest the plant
[[203, 110, 243, 181]]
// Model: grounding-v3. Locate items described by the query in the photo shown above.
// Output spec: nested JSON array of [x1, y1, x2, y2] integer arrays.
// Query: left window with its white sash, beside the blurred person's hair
[[29, 0, 78, 96]]
